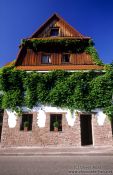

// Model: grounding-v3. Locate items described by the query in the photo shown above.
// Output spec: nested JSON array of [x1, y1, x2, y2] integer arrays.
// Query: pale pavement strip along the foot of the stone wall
[[0, 146, 113, 156]]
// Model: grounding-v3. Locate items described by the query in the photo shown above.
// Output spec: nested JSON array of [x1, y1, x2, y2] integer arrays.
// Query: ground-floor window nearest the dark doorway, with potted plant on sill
[[50, 114, 62, 131]]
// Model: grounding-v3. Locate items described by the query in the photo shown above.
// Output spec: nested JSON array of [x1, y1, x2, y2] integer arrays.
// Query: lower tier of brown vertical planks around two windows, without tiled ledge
[[18, 49, 94, 67]]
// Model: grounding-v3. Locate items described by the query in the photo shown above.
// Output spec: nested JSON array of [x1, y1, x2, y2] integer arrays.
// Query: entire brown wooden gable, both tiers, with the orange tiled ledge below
[[15, 14, 103, 71]]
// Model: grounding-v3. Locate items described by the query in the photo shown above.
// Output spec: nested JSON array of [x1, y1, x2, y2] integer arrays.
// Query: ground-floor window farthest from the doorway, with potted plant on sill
[[20, 114, 33, 131]]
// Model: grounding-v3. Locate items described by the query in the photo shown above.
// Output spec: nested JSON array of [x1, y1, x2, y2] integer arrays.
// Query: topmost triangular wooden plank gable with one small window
[[31, 14, 84, 38]]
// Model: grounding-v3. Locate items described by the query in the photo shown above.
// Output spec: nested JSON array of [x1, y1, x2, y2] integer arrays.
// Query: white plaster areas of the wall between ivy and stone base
[[6, 105, 106, 128]]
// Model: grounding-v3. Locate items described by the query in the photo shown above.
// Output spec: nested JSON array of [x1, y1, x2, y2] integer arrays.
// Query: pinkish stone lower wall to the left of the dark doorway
[[1, 112, 81, 147]]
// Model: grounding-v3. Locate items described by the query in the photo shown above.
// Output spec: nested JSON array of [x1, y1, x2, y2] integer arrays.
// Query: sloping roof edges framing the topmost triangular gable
[[30, 13, 89, 39]]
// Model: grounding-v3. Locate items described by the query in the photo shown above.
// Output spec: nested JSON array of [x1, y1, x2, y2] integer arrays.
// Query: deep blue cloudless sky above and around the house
[[0, 0, 113, 67]]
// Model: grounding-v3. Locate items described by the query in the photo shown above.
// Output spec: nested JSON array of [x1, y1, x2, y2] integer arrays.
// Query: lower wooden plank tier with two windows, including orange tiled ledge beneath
[[16, 48, 103, 71]]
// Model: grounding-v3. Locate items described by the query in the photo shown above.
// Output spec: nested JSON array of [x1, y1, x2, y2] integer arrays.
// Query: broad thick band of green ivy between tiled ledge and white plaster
[[0, 68, 113, 119]]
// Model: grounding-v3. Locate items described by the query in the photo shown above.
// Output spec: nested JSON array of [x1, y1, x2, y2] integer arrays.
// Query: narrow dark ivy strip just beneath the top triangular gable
[[20, 38, 89, 52]]
